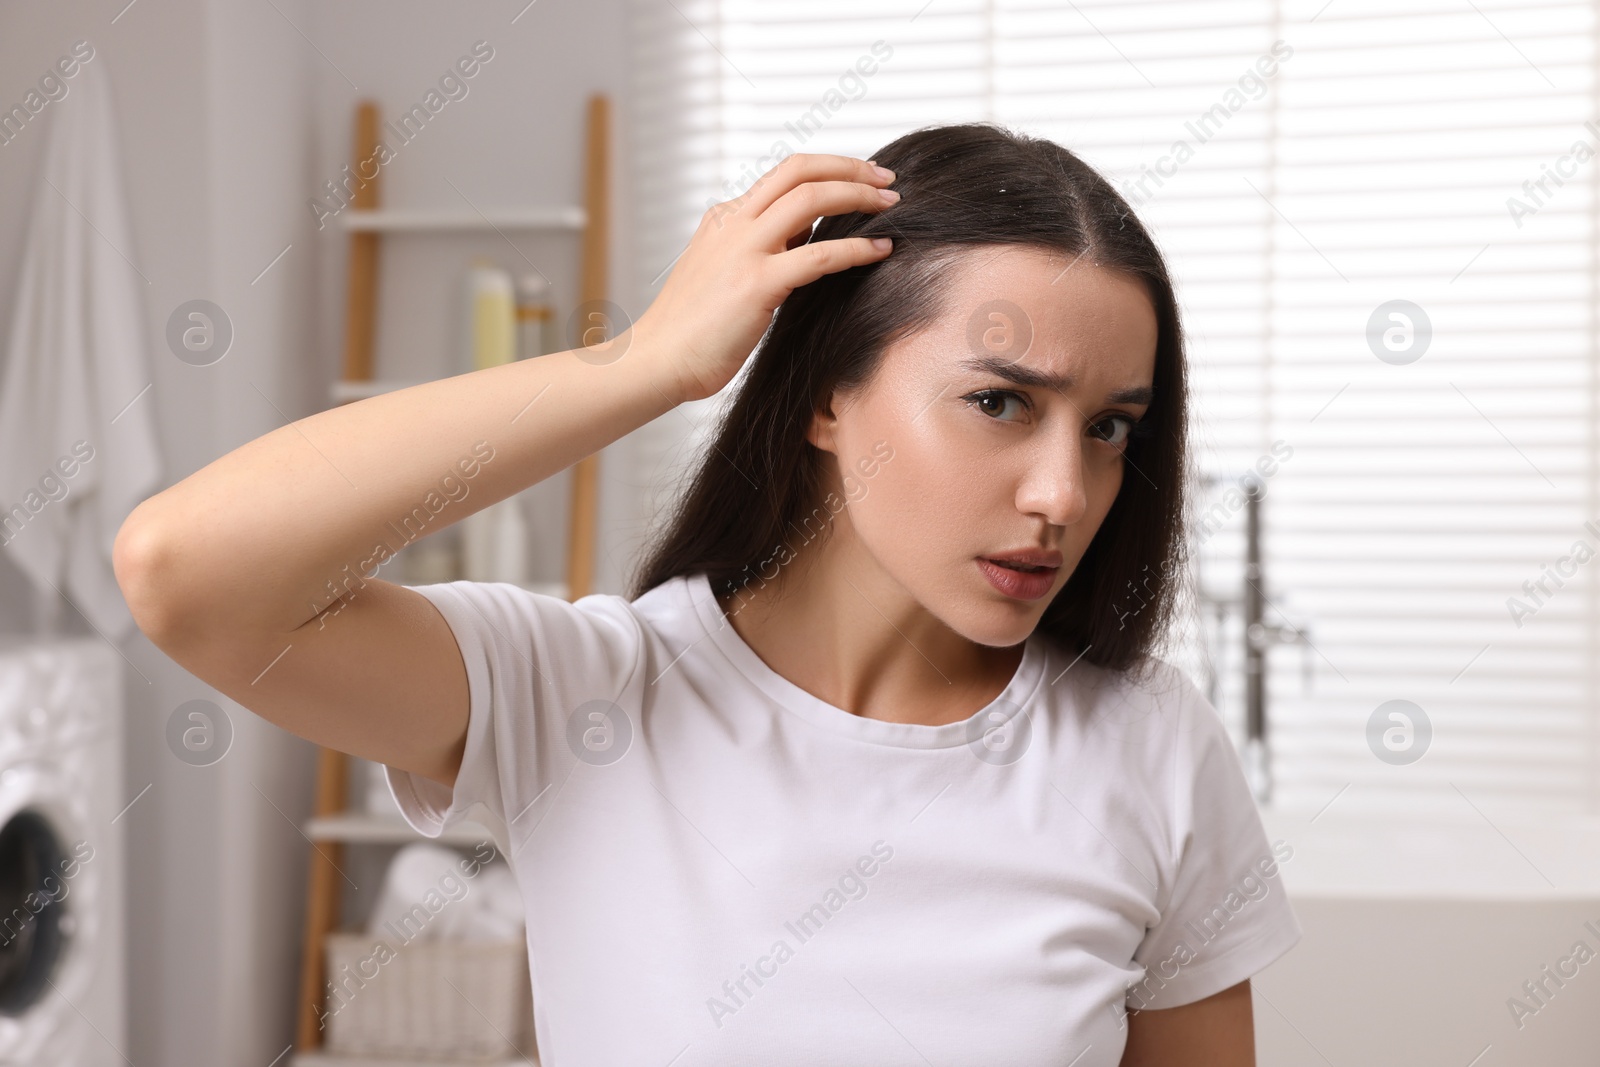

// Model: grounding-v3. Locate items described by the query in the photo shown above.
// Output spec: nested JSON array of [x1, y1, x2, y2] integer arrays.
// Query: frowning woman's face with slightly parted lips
[[810, 245, 1157, 646]]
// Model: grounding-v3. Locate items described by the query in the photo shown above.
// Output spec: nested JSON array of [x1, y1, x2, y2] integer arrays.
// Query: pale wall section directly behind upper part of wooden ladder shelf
[[300, 0, 643, 592]]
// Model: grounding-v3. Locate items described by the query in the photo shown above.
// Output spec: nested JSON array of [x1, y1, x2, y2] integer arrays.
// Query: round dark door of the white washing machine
[[0, 808, 72, 1016]]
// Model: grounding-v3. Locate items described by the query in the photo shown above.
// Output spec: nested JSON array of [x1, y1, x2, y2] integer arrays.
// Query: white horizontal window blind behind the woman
[[632, 0, 1600, 813]]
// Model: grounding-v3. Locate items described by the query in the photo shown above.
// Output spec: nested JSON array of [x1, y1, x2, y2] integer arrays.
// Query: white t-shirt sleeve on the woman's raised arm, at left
[[384, 581, 643, 851]]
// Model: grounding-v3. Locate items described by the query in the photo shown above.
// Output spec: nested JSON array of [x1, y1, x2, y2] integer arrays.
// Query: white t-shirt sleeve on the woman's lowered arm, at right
[[1128, 670, 1301, 1009]]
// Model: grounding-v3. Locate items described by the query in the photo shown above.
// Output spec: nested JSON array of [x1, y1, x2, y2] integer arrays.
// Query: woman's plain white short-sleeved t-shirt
[[386, 574, 1301, 1067]]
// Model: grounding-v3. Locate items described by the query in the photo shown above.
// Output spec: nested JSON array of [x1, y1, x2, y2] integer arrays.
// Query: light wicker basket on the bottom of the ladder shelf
[[323, 933, 533, 1062]]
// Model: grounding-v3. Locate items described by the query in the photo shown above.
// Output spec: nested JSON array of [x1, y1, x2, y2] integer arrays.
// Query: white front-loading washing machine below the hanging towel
[[0, 638, 130, 1067]]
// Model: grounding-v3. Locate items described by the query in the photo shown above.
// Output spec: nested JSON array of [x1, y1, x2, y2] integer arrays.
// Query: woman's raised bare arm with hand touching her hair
[[114, 155, 888, 785]]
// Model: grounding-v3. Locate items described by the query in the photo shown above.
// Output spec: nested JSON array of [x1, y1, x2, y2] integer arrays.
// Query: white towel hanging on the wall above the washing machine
[[0, 56, 162, 641]]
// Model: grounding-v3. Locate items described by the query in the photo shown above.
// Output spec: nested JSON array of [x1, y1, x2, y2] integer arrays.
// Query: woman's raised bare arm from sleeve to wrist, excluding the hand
[[117, 338, 680, 784]]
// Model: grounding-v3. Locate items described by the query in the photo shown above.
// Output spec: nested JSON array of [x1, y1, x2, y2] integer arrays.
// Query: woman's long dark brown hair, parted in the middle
[[630, 123, 1187, 670]]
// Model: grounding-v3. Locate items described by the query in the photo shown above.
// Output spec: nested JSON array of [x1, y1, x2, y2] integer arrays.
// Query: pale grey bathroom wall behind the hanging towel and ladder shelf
[[0, 0, 640, 1067]]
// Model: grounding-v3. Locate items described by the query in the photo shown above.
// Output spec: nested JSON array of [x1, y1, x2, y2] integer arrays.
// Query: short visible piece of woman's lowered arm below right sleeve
[[1122, 979, 1256, 1067]]
